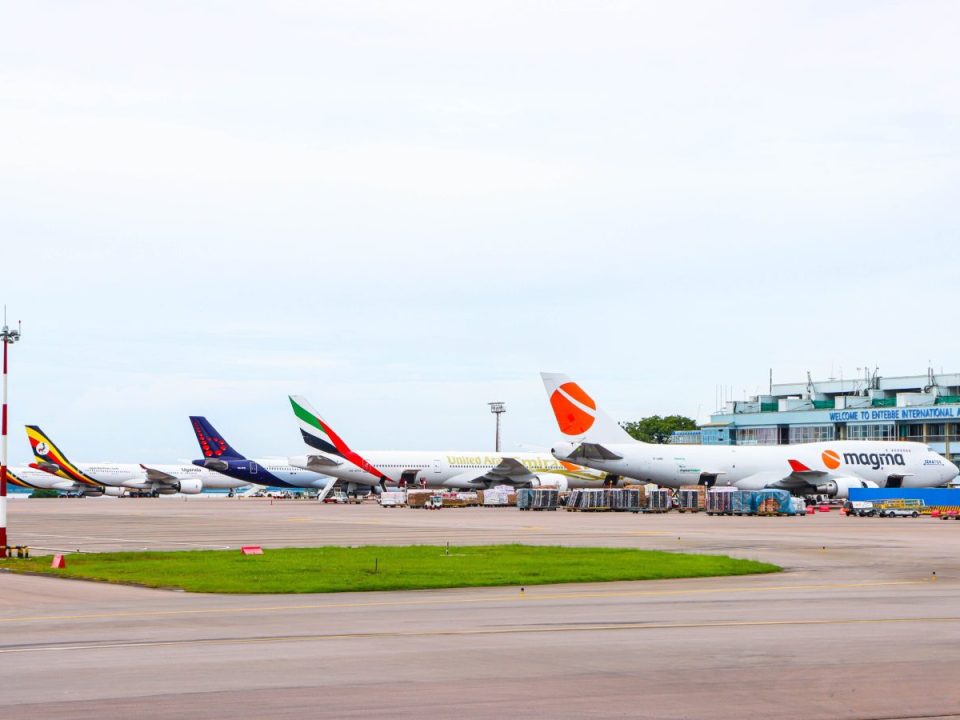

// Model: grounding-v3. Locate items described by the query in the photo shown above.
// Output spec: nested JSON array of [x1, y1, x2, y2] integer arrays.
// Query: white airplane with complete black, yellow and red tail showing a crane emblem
[[27, 425, 248, 495]]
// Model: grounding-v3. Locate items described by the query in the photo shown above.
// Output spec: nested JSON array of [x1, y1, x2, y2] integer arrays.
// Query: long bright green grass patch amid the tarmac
[[0, 545, 780, 593]]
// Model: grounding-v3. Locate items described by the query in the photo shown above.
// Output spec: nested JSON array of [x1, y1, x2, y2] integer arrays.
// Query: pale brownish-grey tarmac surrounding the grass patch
[[0, 497, 960, 720]]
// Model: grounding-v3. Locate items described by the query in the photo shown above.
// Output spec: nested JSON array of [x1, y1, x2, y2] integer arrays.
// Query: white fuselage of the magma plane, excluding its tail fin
[[551, 440, 957, 497]]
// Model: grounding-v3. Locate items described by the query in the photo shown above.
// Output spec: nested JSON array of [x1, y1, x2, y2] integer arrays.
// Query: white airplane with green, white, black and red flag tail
[[290, 396, 606, 490]]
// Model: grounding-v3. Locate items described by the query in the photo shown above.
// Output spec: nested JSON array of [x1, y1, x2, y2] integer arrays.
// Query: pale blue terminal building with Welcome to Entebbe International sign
[[671, 371, 960, 462]]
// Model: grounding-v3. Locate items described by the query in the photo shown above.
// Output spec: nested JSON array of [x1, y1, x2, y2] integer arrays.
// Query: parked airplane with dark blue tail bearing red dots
[[190, 415, 336, 500]]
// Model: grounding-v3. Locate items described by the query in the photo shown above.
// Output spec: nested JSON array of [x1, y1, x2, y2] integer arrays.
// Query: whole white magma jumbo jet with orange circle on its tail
[[541, 373, 958, 498]]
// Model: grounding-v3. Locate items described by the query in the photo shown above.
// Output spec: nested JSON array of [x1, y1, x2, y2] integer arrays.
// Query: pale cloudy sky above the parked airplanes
[[0, 0, 960, 464]]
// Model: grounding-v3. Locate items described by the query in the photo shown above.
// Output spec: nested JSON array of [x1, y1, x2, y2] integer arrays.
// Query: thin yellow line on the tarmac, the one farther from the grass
[[0, 617, 960, 655]]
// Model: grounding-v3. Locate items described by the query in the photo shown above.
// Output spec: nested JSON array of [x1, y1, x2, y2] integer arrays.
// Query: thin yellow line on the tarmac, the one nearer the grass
[[0, 576, 929, 624]]
